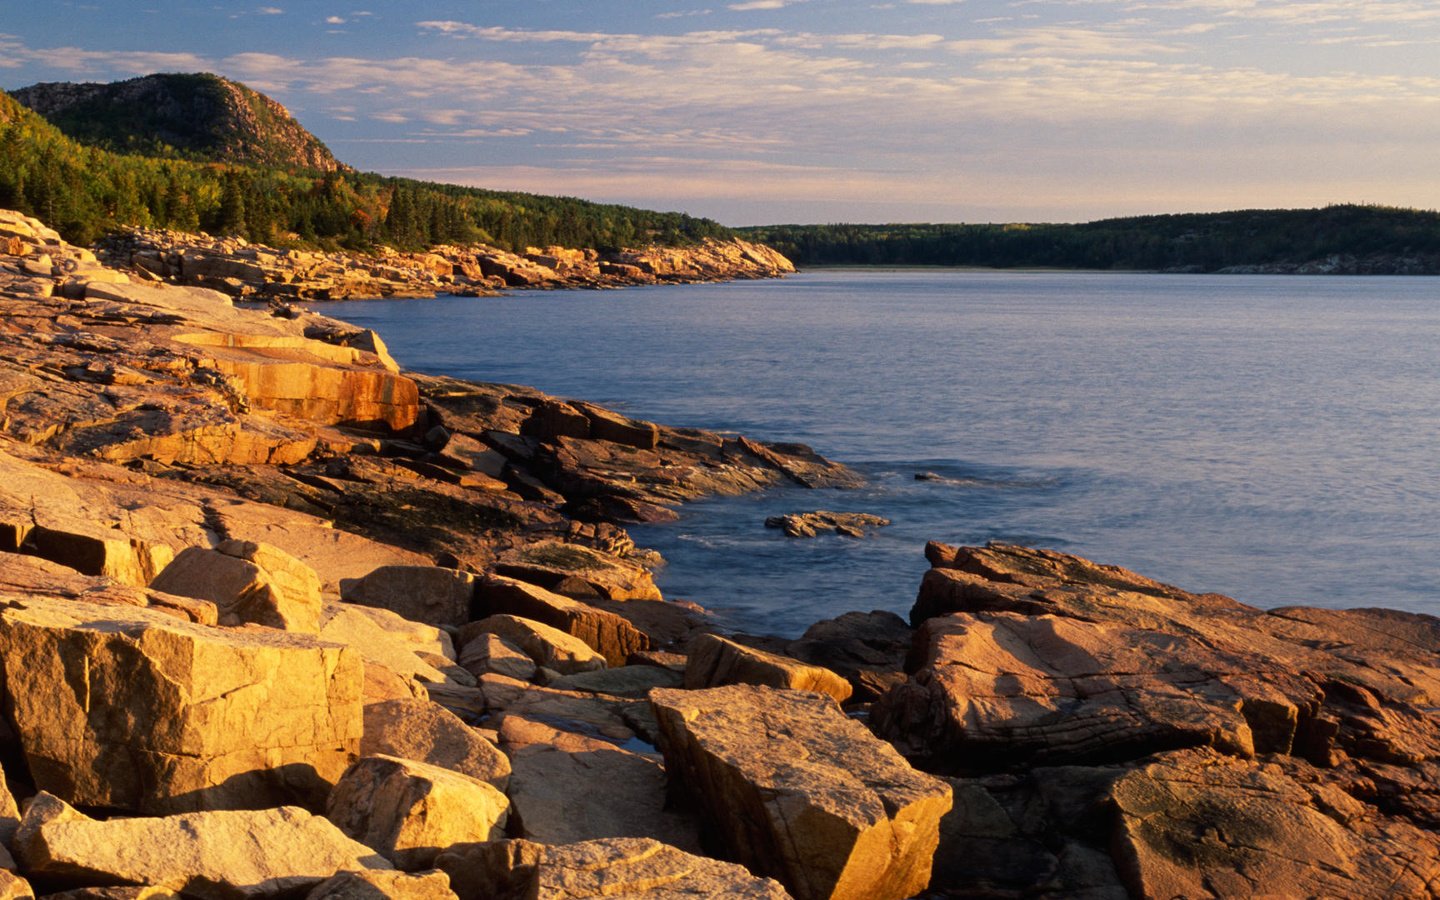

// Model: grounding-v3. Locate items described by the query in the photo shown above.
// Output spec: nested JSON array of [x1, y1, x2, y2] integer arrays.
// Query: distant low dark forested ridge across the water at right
[[736, 206, 1440, 274]]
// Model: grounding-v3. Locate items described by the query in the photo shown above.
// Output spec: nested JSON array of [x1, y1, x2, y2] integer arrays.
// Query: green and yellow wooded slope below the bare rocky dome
[[0, 75, 733, 251]]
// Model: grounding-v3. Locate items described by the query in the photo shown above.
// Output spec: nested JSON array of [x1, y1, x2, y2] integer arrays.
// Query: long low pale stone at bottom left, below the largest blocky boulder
[[14, 793, 390, 900]]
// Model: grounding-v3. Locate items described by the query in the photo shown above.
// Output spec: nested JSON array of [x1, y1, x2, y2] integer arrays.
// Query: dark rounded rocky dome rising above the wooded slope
[[10, 73, 348, 171]]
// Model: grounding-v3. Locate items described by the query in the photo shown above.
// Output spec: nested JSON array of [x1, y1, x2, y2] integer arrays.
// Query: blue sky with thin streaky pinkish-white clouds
[[0, 0, 1440, 225]]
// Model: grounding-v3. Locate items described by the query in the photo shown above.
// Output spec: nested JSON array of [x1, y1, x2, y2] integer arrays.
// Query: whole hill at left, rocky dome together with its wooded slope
[[0, 75, 733, 251]]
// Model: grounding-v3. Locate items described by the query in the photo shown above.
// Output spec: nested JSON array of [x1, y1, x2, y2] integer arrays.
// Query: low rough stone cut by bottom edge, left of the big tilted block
[[436, 838, 789, 900]]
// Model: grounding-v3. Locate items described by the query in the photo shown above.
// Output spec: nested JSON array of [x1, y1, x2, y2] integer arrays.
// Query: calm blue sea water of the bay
[[324, 271, 1440, 634]]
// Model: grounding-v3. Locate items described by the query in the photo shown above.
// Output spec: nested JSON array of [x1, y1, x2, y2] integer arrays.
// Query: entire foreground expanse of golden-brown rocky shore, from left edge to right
[[0, 205, 1440, 900]]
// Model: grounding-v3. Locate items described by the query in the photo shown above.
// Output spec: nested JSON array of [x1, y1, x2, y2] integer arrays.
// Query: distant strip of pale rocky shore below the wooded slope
[[99, 229, 795, 301]]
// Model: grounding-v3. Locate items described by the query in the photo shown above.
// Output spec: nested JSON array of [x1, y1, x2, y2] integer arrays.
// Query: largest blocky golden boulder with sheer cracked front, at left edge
[[0, 598, 363, 812]]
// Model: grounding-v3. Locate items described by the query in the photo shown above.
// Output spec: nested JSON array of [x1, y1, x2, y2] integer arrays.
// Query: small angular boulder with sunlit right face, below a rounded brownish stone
[[325, 756, 510, 871]]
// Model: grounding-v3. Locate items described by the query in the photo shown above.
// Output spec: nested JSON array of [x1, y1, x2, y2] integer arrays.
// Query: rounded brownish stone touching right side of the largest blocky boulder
[[360, 700, 510, 791]]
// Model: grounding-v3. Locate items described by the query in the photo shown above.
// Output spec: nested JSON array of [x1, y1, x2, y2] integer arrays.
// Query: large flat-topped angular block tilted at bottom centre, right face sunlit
[[651, 685, 950, 900]]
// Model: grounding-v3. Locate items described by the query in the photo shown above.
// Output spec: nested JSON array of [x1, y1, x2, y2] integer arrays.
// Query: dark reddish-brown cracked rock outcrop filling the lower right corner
[[871, 544, 1440, 897]]
